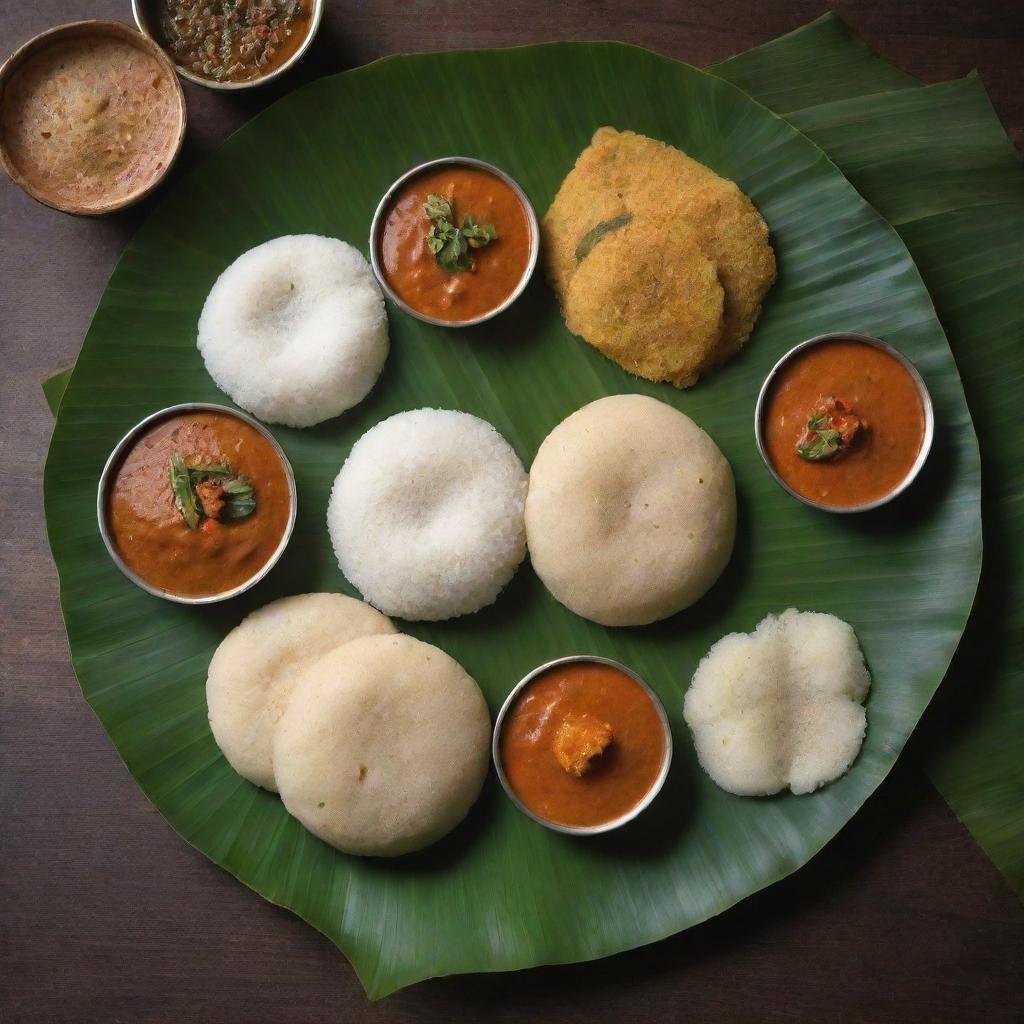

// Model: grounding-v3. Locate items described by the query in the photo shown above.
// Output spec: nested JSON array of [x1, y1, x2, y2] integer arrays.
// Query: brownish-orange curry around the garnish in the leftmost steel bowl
[[106, 412, 291, 597]]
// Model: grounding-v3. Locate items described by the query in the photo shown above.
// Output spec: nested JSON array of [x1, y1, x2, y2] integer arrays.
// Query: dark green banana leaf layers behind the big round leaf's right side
[[713, 15, 1024, 896]]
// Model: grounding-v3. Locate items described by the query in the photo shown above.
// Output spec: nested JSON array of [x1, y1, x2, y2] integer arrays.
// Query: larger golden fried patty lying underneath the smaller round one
[[544, 128, 775, 386]]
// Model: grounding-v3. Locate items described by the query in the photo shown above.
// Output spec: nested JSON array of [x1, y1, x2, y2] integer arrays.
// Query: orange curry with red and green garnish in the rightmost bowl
[[763, 339, 925, 508]]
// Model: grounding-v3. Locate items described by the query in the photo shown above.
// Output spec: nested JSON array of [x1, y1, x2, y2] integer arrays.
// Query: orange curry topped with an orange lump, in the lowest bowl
[[499, 662, 666, 827]]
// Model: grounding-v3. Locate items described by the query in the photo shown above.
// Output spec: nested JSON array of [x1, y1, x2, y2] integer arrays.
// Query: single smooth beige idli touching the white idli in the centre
[[525, 394, 736, 626]]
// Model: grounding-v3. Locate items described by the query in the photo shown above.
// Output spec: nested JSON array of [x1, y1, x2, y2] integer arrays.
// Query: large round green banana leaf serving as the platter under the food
[[45, 44, 981, 996]]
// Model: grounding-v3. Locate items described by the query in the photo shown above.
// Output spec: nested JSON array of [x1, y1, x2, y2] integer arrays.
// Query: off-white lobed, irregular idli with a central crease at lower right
[[683, 608, 871, 797]]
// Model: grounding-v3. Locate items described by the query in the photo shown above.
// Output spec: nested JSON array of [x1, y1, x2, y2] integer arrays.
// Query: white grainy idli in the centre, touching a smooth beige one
[[327, 409, 526, 622]]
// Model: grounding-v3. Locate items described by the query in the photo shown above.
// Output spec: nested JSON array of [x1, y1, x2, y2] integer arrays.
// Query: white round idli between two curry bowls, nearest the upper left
[[199, 234, 388, 427]]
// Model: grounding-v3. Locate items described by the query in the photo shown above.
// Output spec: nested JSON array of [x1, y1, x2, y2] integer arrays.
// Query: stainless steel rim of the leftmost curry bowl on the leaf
[[96, 401, 298, 604]]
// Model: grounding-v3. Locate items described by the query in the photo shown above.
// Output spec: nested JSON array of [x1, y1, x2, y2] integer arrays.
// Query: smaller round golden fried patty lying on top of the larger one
[[563, 218, 724, 387]]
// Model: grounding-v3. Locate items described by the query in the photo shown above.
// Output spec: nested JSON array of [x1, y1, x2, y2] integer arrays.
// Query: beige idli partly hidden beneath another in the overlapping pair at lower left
[[206, 594, 395, 791]]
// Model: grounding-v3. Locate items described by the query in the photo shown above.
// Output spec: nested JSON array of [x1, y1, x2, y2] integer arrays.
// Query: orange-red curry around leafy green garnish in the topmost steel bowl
[[380, 165, 532, 324]]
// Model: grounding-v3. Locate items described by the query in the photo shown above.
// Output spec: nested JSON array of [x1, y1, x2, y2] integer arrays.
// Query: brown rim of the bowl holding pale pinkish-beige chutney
[[0, 18, 188, 217]]
